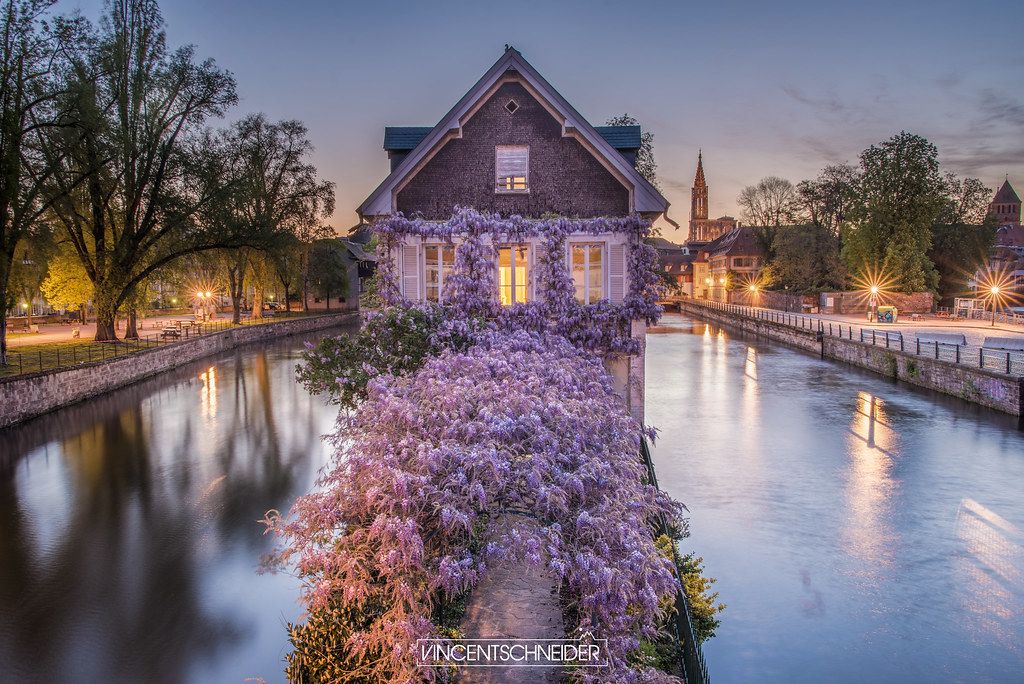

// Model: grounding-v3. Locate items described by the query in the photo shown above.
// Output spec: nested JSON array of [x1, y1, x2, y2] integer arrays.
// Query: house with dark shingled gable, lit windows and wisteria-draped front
[[357, 47, 669, 416]]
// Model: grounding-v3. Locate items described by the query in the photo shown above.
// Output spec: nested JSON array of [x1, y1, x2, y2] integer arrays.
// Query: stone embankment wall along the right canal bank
[[680, 301, 1024, 416]]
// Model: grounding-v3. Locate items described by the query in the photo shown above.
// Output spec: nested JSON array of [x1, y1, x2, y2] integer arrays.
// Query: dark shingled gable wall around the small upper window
[[396, 82, 630, 219]]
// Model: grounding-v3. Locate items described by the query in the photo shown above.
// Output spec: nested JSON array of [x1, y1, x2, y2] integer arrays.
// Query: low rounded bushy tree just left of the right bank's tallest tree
[[771, 223, 846, 292]]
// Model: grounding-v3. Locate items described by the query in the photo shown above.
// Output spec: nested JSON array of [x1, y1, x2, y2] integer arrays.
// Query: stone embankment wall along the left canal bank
[[0, 312, 358, 428]]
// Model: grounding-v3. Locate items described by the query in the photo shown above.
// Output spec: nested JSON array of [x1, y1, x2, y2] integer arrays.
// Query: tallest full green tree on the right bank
[[843, 131, 946, 292]]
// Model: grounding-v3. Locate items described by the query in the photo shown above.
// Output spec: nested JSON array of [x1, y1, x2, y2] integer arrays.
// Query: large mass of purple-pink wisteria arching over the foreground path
[[269, 330, 681, 682]]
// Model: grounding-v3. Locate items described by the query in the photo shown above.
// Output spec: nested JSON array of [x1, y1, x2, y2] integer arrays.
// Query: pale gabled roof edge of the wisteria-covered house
[[357, 47, 669, 216]]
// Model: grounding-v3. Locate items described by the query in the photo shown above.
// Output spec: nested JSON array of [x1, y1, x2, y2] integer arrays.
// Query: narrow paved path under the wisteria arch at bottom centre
[[459, 517, 565, 684]]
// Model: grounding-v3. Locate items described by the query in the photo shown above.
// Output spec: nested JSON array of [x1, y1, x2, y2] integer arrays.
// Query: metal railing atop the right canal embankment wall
[[687, 300, 1024, 376]]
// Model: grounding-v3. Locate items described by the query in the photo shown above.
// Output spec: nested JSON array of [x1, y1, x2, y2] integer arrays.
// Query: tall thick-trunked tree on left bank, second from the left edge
[[45, 0, 238, 340]]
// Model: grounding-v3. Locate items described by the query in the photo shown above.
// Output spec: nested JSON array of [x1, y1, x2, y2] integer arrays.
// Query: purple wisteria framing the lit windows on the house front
[[374, 208, 663, 354]]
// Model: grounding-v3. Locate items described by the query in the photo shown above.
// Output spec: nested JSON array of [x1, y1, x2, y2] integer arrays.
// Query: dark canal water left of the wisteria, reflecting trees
[[0, 327, 354, 682]]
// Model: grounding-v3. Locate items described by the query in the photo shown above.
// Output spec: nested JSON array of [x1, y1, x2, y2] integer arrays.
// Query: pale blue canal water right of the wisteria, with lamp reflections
[[646, 315, 1024, 684]]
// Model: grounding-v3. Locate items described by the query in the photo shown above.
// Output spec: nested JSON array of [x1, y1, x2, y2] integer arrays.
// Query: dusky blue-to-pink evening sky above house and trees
[[59, 0, 1024, 241]]
